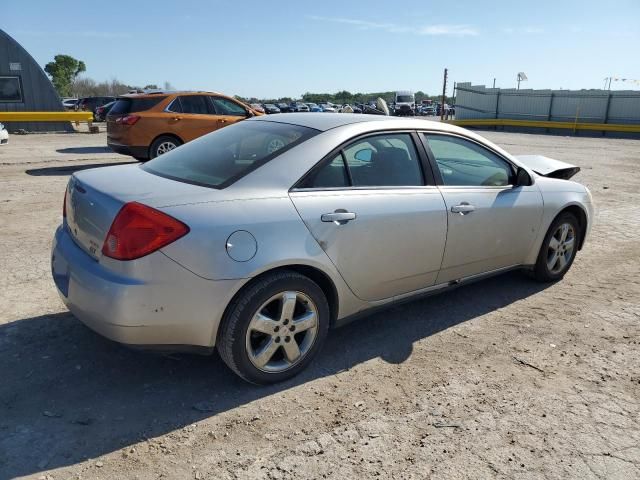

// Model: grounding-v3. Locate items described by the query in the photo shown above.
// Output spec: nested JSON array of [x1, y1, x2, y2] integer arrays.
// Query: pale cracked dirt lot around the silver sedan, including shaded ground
[[0, 128, 640, 480]]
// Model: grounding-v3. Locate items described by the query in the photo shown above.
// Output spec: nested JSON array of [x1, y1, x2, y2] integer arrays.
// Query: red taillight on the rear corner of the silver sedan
[[102, 202, 189, 260]]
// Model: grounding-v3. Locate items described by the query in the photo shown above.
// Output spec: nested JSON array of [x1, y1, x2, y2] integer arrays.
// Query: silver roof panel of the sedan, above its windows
[[248, 112, 457, 132]]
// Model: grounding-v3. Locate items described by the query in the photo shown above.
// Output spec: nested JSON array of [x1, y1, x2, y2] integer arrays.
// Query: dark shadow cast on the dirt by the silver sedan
[[0, 272, 545, 478]]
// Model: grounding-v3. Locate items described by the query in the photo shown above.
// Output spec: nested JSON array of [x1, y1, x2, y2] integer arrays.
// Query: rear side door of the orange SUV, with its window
[[163, 95, 218, 142]]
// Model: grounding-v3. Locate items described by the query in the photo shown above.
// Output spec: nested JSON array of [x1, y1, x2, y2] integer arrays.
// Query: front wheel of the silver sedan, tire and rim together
[[532, 212, 580, 282]]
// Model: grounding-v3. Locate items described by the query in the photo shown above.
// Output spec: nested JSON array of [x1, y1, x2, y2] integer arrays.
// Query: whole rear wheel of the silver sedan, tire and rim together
[[217, 270, 330, 385]]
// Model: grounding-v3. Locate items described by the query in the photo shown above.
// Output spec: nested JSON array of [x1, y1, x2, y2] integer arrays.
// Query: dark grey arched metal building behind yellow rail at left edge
[[0, 30, 73, 132]]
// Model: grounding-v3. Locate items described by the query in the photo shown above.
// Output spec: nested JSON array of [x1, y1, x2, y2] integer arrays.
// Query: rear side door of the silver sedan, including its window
[[290, 132, 447, 301]]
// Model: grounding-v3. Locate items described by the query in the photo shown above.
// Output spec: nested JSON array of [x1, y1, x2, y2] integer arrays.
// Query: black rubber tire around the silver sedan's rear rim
[[219, 272, 330, 385]]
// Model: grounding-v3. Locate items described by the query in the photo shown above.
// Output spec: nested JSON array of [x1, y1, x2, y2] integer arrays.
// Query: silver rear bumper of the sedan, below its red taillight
[[51, 226, 242, 347]]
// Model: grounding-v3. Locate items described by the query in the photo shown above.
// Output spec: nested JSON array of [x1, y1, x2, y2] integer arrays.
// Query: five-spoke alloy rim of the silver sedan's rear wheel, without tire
[[246, 291, 318, 373]]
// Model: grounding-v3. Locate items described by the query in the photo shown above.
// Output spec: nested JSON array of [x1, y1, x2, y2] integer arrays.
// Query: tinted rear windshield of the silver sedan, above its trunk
[[141, 120, 319, 188]]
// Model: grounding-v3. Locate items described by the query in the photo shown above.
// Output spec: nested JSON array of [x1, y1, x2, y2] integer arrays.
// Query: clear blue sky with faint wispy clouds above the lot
[[0, 0, 640, 97]]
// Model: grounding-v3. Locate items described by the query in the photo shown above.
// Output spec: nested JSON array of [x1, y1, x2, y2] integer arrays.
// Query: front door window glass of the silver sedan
[[425, 134, 514, 187]]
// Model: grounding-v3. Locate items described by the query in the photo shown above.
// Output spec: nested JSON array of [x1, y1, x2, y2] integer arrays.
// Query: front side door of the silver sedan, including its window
[[423, 133, 543, 283]]
